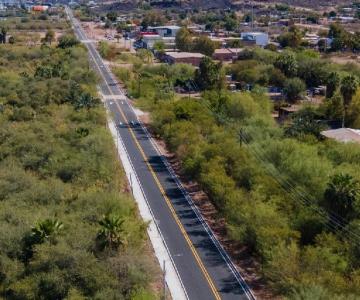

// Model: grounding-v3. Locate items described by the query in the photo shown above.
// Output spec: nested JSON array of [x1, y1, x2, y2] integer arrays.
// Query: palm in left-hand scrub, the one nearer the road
[[98, 215, 126, 250]]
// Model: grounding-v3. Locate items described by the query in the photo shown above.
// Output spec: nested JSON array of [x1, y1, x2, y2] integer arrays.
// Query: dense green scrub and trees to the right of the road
[[114, 51, 360, 299]]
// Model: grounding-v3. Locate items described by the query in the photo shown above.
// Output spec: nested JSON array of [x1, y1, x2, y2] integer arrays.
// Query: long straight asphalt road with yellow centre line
[[68, 10, 254, 300]]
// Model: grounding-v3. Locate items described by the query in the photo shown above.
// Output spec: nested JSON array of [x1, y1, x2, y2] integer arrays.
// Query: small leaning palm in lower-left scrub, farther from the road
[[31, 219, 64, 244]]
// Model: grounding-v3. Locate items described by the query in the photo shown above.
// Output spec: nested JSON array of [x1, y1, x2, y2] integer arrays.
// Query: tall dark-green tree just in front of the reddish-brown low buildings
[[195, 56, 224, 90]]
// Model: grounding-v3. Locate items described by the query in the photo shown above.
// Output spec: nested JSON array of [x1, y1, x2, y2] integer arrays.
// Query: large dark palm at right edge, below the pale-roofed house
[[324, 173, 360, 221]]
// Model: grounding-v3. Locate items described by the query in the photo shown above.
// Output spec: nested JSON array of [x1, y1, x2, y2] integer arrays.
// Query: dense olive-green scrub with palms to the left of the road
[[0, 29, 157, 299]]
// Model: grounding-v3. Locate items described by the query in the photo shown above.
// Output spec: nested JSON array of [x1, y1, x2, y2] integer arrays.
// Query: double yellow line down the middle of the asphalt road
[[84, 34, 221, 300]]
